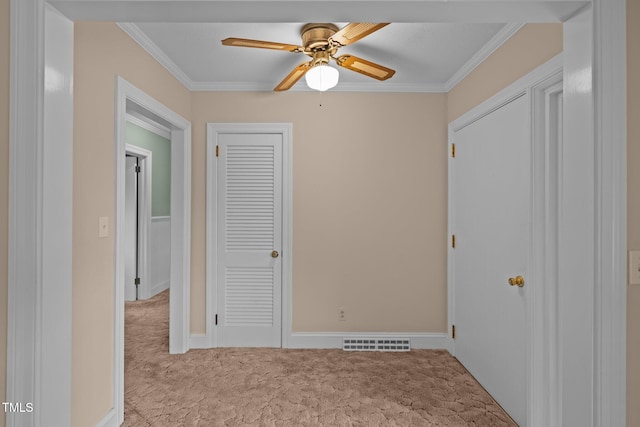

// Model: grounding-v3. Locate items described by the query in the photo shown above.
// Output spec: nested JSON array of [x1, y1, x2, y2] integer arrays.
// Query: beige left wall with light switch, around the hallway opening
[[71, 23, 191, 427]]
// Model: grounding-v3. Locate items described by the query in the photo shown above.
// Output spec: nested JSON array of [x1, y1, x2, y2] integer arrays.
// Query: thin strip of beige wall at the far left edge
[[0, 0, 10, 427]]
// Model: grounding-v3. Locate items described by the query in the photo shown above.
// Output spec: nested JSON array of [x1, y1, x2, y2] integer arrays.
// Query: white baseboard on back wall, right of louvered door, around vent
[[288, 332, 451, 350]]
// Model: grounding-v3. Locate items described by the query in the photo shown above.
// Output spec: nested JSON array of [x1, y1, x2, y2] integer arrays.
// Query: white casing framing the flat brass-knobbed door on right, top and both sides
[[447, 54, 563, 426]]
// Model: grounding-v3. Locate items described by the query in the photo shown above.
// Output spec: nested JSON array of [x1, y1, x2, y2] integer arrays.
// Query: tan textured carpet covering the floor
[[123, 291, 516, 427]]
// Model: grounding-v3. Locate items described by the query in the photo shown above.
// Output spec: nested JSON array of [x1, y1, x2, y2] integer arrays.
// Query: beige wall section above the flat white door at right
[[447, 24, 562, 122]]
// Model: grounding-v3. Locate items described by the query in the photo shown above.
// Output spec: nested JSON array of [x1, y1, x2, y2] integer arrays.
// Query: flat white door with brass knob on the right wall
[[452, 96, 532, 426]]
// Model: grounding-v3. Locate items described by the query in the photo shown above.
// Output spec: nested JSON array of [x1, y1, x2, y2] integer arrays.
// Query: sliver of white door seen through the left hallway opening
[[124, 156, 138, 301]]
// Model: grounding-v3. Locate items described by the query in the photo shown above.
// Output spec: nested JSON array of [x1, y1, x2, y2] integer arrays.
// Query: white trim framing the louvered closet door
[[205, 123, 293, 348]]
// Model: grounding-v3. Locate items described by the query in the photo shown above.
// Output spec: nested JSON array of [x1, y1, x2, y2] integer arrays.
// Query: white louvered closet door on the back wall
[[216, 132, 283, 347]]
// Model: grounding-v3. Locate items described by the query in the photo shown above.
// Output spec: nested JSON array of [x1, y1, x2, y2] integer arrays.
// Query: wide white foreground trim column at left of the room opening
[[3, 4, 74, 426]]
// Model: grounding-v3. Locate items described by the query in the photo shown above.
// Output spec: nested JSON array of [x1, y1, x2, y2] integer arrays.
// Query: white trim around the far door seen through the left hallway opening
[[126, 144, 153, 299]]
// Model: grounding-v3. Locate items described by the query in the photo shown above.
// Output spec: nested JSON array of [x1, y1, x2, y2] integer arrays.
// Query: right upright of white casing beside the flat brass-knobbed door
[[527, 77, 563, 427]]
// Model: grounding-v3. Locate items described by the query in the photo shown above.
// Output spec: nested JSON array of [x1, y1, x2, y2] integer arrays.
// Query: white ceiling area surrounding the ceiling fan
[[120, 22, 520, 92]]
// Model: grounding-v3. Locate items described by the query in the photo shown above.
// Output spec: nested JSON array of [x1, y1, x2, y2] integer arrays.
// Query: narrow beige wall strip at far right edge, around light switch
[[627, 0, 640, 427]]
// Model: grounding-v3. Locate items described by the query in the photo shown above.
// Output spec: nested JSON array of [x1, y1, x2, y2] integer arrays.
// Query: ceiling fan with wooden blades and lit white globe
[[222, 22, 395, 91]]
